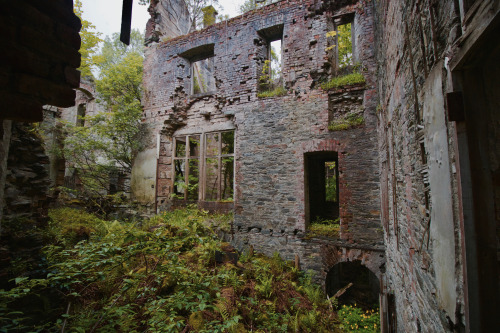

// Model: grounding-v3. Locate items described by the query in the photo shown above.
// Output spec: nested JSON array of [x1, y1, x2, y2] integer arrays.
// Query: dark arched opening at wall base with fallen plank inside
[[325, 260, 380, 309]]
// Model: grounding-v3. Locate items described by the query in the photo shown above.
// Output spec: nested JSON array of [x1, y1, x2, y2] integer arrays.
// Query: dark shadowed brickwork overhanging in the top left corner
[[0, 0, 81, 121]]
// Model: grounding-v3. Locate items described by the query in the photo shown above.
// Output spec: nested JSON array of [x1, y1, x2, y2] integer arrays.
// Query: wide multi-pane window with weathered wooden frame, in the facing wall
[[173, 131, 234, 201]]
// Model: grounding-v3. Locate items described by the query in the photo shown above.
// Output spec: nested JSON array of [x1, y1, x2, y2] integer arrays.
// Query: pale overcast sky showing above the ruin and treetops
[[82, 0, 244, 38]]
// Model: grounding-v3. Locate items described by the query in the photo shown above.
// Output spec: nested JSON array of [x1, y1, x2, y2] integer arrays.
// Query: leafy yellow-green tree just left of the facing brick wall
[[63, 33, 145, 212]]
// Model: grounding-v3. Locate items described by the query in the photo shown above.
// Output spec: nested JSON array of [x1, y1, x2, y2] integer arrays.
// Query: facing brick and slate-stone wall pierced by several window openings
[[144, 0, 384, 282]]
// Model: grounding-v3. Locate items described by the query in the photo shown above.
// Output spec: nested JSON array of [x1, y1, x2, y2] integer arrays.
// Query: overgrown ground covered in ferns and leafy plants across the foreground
[[0, 208, 380, 332]]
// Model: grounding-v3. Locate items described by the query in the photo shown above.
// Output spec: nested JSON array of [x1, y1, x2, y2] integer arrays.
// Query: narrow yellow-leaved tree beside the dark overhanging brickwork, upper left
[[73, 0, 102, 77]]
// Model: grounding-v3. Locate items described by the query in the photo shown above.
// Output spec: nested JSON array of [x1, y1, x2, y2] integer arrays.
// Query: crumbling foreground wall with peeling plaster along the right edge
[[376, 1, 499, 332]]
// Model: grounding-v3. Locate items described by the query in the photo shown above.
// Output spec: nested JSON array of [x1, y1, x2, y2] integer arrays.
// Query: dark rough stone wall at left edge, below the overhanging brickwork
[[0, 122, 51, 287]]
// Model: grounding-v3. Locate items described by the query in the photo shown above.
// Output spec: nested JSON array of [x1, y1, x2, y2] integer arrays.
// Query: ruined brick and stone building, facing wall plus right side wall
[[132, 0, 500, 332]]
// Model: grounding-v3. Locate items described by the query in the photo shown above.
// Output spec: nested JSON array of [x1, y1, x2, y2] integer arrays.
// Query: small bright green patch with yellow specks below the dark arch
[[338, 304, 380, 333]]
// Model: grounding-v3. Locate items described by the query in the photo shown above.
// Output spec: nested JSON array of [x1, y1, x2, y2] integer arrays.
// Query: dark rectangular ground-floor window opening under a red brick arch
[[305, 152, 339, 224]]
